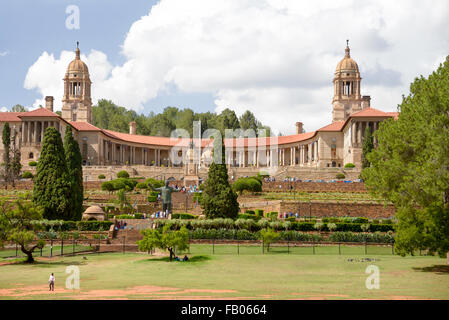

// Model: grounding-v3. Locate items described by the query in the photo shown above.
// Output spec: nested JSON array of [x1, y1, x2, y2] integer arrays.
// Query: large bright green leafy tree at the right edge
[[362, 56, 449, 257]]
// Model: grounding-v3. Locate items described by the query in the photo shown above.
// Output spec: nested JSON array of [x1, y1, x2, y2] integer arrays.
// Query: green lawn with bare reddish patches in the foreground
[[0, 245, 449, 299]]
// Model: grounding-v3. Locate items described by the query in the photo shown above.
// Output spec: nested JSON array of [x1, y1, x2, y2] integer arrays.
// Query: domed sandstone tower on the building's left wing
[[62, 42, 92, 123]]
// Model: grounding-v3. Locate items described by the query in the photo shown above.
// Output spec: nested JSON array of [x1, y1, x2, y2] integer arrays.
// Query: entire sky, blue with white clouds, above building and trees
[[0, 0, 449, 134]]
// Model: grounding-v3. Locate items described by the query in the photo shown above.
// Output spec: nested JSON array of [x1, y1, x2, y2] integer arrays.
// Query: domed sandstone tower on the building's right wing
[[332, 40, 370, 122]]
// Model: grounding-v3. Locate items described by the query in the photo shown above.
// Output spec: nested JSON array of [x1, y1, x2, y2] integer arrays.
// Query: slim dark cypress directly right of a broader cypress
[[64, 126, 84, 221]]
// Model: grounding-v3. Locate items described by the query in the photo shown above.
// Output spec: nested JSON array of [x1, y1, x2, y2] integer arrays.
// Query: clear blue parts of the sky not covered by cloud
[[0, 0, 213, 113]]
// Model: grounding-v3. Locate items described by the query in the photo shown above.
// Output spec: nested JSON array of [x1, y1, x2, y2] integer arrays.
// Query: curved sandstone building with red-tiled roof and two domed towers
[[0, 46, 398, 180]]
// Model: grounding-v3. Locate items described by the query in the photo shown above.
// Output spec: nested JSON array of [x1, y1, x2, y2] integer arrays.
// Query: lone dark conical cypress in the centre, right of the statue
[[201, 139, 239, 219]]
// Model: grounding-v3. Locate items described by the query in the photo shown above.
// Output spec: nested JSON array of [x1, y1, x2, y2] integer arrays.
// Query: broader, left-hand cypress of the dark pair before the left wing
[[33, 127, 71, 220]]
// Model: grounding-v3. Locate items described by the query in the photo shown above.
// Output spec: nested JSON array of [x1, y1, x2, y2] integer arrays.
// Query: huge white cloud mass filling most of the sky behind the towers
[[25, 0, 449, 134]]
